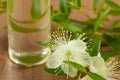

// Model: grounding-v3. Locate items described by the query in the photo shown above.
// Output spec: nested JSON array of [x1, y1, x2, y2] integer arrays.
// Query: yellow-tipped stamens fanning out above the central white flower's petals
[[51, 28, 87, 47]]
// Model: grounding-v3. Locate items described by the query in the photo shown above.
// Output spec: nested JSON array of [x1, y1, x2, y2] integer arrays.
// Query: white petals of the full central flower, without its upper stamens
[[47, 40, 90, 77]]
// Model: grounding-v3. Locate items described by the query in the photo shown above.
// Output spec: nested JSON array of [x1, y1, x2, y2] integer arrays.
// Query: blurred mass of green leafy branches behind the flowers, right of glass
[[51, 0, 120, 59]]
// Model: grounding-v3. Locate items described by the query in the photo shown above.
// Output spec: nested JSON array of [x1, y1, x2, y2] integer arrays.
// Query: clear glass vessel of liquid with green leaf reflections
[[7, 0, 51, 67]]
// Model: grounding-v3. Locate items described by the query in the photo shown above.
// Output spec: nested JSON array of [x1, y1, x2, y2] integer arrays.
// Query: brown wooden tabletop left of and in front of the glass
[[0, 30, 75, 80]]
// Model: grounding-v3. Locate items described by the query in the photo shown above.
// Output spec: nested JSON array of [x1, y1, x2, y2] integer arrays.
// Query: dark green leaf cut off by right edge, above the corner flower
[[103, 34, 120, 50]]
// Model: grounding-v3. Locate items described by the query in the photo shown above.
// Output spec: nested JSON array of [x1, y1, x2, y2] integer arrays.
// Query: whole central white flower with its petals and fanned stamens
[[46, 30, 90, 77]]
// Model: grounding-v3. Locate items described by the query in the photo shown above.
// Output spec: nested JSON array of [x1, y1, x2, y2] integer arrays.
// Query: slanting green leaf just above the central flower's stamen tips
[[56, 21, 80, 32]]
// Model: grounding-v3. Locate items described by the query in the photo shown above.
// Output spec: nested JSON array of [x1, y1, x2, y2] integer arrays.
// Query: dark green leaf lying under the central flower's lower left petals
[[44, 68, 66, 76]]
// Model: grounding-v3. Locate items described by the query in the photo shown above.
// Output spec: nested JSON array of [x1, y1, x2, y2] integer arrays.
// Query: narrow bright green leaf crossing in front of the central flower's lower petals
[[64, 61, 87, 73]]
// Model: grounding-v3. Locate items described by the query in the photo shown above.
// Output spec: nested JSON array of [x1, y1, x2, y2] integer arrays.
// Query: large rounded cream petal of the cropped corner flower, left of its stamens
[[89, 56, 106, 77]]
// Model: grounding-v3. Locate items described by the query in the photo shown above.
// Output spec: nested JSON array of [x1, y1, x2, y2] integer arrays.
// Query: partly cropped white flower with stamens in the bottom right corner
[[81, 55, 120, 80]]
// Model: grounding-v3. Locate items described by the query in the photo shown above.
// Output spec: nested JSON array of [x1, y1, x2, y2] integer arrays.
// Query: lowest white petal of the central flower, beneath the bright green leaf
[[61, 63, 78, 77]]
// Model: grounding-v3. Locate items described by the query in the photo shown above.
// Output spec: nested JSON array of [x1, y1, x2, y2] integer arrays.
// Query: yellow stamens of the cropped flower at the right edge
[[106, 58, 120, 79]]
